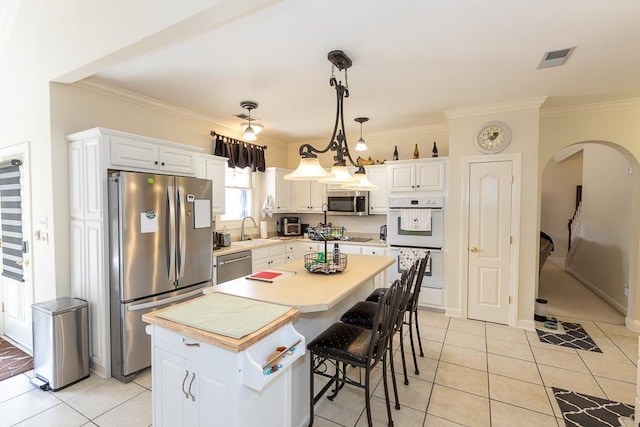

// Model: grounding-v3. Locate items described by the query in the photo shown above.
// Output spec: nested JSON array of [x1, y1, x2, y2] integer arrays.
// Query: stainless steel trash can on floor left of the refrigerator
[[31, 298, 89, 391]]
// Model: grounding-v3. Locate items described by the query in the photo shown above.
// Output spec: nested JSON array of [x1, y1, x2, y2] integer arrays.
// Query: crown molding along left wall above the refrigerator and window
[[71, 78, 287, 148]]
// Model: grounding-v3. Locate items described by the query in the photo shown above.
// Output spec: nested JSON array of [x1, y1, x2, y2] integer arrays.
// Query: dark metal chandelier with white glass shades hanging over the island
[[284, 50, 378, 190]]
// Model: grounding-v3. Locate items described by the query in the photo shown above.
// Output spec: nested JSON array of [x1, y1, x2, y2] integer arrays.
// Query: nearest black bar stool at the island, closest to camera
[[307, 280, 402, 426]]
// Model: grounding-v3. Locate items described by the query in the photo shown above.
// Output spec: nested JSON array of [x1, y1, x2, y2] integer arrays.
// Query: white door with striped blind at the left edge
[[0, 144, 33, 349]]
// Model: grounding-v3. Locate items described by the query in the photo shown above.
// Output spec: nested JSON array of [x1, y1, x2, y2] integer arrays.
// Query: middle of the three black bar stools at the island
[[340, 260, 419, 390]]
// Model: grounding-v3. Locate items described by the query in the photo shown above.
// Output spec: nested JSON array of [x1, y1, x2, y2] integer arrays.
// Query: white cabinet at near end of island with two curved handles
[[147, 323, 305, 427]]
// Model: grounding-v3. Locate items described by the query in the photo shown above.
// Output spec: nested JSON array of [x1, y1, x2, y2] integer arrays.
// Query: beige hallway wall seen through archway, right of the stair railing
[[567, 143, 634, 314]]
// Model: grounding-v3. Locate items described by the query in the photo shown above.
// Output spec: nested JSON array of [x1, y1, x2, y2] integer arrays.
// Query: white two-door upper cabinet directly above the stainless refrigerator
[[106, 134, 201, 176]]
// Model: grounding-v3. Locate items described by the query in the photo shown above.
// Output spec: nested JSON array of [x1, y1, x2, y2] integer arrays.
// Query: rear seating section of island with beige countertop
[[215, 254, 395, 426]]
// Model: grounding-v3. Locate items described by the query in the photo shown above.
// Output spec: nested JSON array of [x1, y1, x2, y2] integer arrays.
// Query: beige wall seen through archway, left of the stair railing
[[540, 150, 582, 262]]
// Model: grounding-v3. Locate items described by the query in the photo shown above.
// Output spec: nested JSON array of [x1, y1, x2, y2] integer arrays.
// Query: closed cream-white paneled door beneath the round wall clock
[[467, 161, 513, 324]]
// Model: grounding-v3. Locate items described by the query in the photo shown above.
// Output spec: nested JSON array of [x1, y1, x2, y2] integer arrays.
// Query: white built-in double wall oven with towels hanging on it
[[387, 197, 444, 306]]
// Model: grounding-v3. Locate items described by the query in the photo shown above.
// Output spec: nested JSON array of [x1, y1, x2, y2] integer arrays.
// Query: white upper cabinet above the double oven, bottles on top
[[387, 158, 447, 194]]
